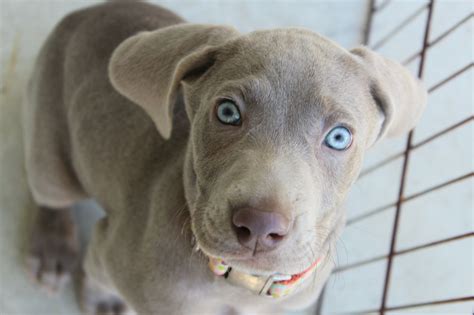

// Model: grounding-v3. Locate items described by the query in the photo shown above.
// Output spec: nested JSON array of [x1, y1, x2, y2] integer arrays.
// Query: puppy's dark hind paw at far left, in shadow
[[26, 208, 79, 293]]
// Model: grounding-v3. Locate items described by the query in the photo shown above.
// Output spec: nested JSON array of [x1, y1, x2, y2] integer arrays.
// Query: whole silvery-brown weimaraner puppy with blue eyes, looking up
[[24, 2, 426, 314]]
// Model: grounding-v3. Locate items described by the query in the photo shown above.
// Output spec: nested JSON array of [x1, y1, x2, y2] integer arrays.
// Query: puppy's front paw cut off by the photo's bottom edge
[[80, 272, 134, 315]]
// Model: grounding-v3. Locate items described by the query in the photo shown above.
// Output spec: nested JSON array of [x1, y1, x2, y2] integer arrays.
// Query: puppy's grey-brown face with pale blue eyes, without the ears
[[185, 31, 382, 274]]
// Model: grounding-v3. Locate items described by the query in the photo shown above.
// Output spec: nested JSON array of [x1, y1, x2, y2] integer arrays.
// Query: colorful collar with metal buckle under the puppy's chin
[[209, 257, 322, 298]]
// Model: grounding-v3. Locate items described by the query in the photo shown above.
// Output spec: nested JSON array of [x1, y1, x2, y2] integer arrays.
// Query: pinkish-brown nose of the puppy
[[232, 208, 290, 250]]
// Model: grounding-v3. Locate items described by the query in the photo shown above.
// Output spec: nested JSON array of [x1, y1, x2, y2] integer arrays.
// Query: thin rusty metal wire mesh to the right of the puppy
[[317, 0, 474, 314]]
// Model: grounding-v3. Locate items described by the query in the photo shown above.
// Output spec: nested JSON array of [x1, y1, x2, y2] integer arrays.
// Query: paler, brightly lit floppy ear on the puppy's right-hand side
[[351, 47, 427, 139]]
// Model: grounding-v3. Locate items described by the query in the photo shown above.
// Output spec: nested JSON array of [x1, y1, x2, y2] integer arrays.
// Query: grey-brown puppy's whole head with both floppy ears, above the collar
[[109, 24, 426, 274]]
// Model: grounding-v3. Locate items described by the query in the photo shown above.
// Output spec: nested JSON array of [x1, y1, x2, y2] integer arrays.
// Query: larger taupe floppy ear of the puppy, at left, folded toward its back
[[109, 24, 238, 139]]
